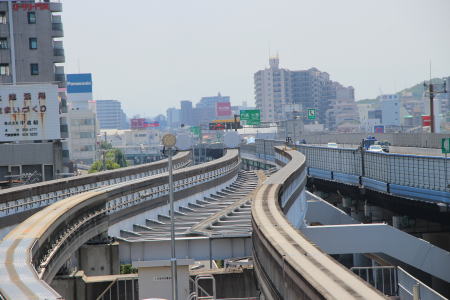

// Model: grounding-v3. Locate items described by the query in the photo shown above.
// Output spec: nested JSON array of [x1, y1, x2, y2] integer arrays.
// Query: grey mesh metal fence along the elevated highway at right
[[298, 145, 450, 192]]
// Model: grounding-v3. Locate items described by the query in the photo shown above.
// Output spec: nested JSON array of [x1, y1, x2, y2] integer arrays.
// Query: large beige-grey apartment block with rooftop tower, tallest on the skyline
[[254, 57, 336, 124]]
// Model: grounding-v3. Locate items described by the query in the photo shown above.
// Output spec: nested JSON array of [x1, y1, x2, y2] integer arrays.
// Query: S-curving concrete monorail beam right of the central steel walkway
[[252, 147, 384, 299]]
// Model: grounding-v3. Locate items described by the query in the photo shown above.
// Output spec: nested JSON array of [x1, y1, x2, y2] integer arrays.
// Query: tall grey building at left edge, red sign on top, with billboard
[[0, 0, 70, 181]]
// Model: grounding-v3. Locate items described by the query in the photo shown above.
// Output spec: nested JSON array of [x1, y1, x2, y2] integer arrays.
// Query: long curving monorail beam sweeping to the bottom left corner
[[0, 150, 240, 299]]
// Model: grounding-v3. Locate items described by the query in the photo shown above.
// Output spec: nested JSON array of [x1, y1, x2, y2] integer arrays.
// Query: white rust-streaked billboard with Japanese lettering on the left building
[[0, 84, 61, 142]]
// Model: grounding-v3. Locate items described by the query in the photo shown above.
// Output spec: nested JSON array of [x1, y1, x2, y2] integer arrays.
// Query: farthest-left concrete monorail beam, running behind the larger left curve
[[0, 151, 191, 231]]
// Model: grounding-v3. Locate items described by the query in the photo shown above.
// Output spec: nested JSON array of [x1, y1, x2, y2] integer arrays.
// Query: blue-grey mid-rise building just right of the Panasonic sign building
[[95, 100, 127, 129]]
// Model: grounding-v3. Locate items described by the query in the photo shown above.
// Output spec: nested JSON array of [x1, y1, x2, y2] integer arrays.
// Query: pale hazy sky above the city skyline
[[63, 0, 450, 117]]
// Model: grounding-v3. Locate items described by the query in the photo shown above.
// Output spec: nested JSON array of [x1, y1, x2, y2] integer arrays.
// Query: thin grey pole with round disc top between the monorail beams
[[162, 133, 178, 300]]
